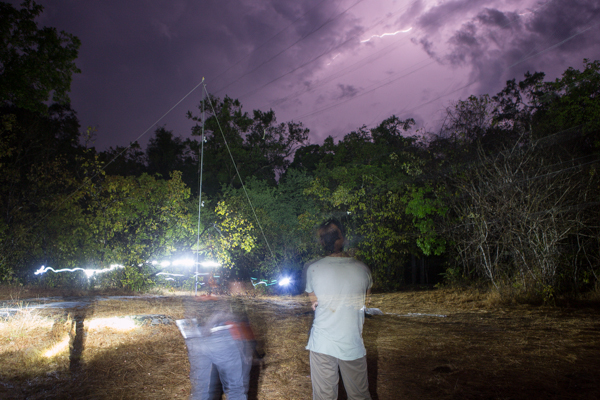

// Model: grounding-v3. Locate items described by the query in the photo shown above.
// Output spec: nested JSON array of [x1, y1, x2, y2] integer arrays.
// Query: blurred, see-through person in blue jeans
[[177, 296, 255, 400]]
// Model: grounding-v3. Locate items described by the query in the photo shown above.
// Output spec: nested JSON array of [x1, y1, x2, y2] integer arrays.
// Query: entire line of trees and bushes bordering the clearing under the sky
[[0, 1, 600, 301]]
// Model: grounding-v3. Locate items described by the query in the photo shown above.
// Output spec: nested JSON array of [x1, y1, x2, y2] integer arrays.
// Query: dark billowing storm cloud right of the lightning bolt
[[413, 0, 600, 94]]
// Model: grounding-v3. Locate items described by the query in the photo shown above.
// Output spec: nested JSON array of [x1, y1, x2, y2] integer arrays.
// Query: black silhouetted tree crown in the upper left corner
[[0, 0, 80, 112]]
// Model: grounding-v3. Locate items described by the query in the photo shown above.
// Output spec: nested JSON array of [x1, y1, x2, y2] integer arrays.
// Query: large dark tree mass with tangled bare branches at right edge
[[426, 60, 600, 301]]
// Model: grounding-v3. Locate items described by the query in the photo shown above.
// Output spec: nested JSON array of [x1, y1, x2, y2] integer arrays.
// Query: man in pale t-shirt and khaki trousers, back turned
[[306, 219, 372, 400]]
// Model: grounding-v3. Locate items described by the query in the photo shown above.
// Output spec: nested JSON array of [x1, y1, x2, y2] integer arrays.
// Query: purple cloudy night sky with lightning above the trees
[[10, 0, 600, 150]]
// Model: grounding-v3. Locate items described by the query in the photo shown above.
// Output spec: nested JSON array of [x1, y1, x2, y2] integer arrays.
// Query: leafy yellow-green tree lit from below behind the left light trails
[[40, 172, 195, 290]]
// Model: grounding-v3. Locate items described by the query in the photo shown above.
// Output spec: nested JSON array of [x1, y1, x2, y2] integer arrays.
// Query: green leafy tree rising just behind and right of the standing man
[[305, 116, 423, 288]]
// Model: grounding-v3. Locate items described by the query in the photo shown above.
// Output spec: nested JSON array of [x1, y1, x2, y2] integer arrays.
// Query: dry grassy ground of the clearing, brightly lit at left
[[0, 289, 600, 400]]
